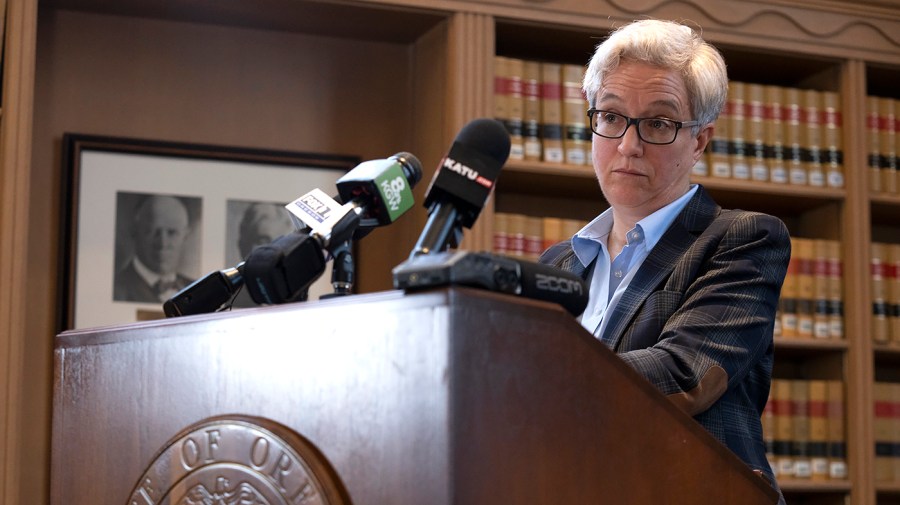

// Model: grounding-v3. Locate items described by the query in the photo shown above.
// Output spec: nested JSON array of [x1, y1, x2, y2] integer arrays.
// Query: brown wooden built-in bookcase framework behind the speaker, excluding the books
[[0, 0, 900, 505]]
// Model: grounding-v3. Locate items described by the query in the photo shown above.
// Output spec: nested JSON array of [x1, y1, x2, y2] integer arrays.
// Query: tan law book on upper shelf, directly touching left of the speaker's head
[[562, 64, 592, 165]]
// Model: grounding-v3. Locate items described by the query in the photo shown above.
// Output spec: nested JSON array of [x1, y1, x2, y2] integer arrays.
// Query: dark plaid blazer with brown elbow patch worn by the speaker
[[541, 186, 791, 486]]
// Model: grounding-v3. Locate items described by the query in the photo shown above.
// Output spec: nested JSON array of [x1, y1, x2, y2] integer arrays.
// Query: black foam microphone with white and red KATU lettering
[[410, 118, 510, 257]]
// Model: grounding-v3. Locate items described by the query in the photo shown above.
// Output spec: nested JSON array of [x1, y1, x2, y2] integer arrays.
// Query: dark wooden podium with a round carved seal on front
[[51, 288, 777, 505]]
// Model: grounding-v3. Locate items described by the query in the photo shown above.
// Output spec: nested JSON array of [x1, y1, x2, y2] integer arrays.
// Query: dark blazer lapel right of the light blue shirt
[[600, 186, 721, 350]]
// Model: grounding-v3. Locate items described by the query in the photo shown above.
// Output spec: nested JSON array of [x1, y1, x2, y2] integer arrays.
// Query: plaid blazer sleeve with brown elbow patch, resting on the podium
[[616, 211, 791, 415]]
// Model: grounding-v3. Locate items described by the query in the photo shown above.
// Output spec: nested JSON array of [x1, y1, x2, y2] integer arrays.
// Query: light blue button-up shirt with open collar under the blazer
[[572, 184, 697, 337]]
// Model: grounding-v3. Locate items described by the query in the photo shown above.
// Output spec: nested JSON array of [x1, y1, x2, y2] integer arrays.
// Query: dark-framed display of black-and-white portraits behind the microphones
[[59, 133, 359, 329]]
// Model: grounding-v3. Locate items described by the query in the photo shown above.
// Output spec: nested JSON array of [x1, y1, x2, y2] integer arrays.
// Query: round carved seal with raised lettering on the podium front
[[128, 415, 350, 505]]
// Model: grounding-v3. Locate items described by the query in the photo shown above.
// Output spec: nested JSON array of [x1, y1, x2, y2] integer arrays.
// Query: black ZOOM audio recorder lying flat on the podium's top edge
[[393, 251, 588, 317]]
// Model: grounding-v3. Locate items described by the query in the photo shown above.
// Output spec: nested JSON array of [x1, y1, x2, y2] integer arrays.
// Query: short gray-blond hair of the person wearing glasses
[[583, 19, 728, 132]]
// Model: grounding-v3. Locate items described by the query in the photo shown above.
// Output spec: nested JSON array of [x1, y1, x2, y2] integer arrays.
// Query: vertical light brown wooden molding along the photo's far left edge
[[0, 0, 37, 505]]
